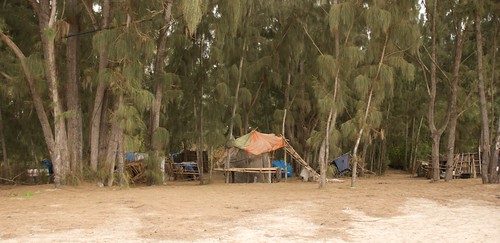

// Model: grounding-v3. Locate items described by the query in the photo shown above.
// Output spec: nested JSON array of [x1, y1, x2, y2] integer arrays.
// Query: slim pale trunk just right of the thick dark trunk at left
[[89, 0, 111, 171]]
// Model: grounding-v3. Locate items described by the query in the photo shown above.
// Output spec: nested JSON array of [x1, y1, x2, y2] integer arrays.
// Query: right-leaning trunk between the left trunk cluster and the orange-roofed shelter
[[149, 0, 173, 149]]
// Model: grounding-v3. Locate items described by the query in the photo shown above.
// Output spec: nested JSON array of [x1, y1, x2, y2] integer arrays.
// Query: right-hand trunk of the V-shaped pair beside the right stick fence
[[445, 22, 465, 181]]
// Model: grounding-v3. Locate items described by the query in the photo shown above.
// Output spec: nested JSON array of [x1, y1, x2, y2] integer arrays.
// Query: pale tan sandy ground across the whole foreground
[[0, 172, 500, 242]]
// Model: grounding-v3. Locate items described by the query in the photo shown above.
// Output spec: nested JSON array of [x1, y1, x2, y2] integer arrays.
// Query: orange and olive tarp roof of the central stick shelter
[[234, 130, 285, 155]]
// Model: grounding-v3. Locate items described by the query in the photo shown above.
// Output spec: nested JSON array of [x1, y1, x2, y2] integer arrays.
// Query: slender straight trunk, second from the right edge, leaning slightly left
[[475, 10, 491, 184]]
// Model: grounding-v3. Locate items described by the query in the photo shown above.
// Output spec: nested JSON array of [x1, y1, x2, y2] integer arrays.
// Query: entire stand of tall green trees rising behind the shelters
[[0, 0, 500, 185]]
